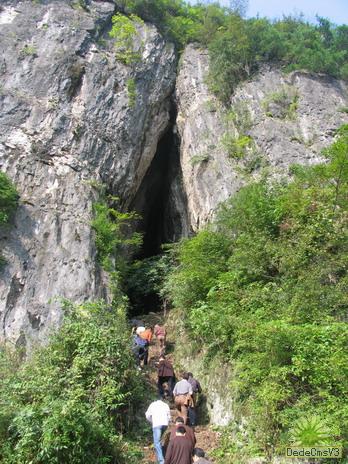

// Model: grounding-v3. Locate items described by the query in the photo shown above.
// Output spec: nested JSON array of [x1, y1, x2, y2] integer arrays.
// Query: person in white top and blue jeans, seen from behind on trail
[[145, 398, 170, 464]]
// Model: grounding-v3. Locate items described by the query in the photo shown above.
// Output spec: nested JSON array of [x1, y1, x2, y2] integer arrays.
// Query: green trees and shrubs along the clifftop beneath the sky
[[119, 0, 348, 103]]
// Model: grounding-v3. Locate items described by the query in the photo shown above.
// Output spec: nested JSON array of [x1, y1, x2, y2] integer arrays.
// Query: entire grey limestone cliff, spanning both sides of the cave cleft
[[0, 0, 348, 352]]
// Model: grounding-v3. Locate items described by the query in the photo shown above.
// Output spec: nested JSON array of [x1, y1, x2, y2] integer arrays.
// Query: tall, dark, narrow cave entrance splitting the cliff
[[127, 105, 189, 316]]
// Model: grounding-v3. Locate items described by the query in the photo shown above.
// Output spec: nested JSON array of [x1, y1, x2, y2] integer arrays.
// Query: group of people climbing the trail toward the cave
[[133, 321, 211, 464]]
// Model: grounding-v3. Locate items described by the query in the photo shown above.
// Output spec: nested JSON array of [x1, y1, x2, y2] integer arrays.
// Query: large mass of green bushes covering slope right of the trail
[[165, 126, 348, 464]]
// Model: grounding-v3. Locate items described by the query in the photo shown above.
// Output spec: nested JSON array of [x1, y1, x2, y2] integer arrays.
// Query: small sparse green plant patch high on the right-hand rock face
[[263, 85, 299, 119]]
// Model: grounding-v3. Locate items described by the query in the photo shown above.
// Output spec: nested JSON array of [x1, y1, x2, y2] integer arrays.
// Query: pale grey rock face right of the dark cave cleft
[[176, 45, 348, 230]]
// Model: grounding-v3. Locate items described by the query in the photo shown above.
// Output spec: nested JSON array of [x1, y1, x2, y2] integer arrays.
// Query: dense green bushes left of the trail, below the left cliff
[[0, 300, 145, 464]]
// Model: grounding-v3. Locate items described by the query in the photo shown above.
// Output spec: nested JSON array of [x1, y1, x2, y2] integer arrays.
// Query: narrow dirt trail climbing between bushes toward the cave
[[139, 313, 219, 464]]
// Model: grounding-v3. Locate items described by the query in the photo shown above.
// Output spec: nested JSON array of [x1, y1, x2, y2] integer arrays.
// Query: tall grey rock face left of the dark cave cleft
[[0, 0, 176, 345]]
